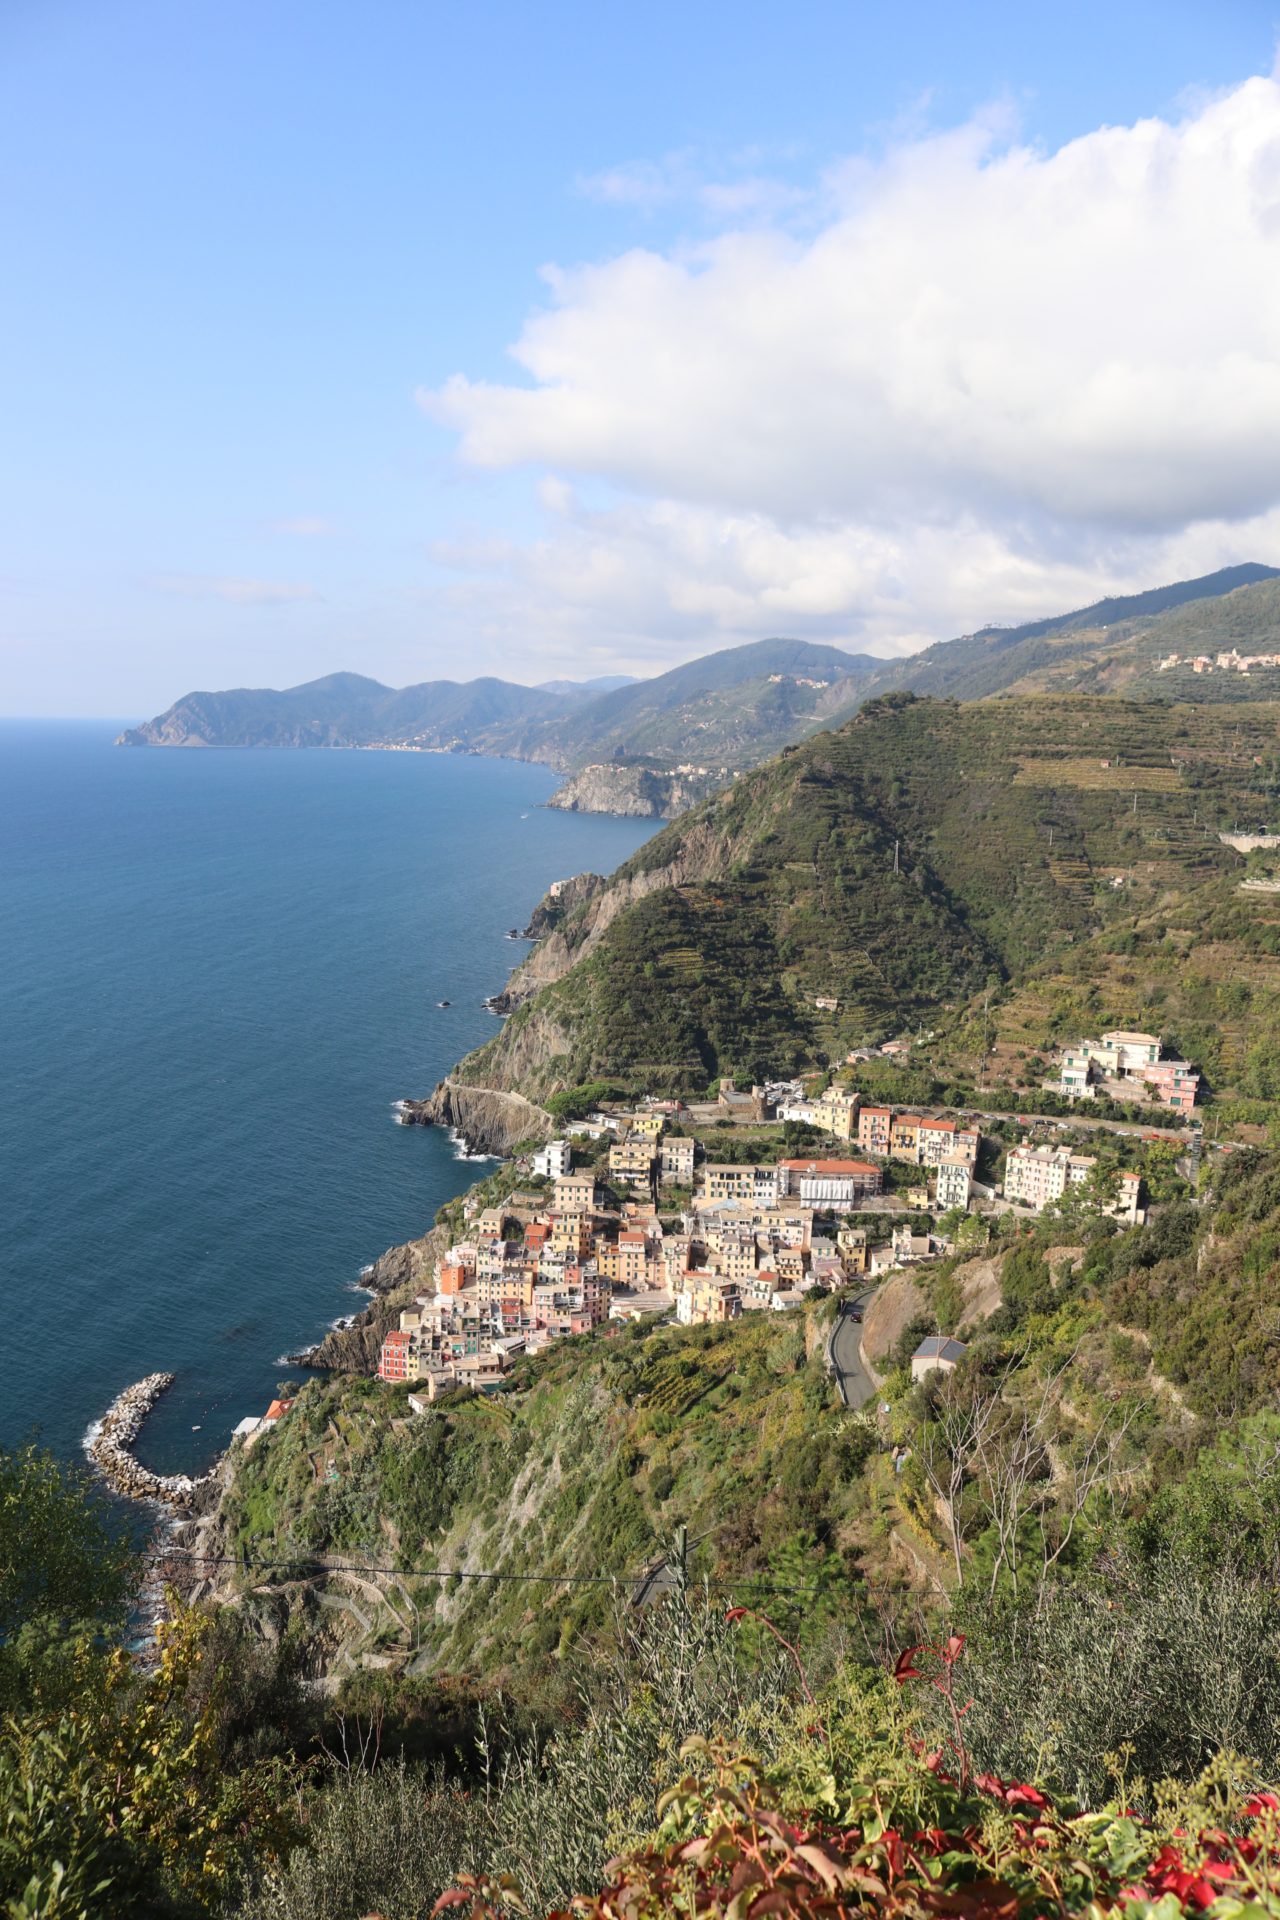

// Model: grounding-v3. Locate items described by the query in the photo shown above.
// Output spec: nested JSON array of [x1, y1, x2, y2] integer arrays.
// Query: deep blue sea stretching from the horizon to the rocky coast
[[0, 722, 652, 1473]]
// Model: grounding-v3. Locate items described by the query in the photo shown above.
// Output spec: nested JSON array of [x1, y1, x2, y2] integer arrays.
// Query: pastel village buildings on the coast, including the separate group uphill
[[347, 1031, 1199, 1407]]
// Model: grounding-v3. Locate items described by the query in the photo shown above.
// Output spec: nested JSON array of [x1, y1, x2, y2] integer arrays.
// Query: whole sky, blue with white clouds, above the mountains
[[0, 0, 1280, 718]]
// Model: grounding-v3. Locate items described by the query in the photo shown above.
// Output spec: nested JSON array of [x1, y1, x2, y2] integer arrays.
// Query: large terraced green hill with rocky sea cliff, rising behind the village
[[449, 695, 1280, 1098]]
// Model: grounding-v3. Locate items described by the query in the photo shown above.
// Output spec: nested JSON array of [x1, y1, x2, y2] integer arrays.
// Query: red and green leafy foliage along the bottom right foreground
[[434, 1636, 1280, 1920]]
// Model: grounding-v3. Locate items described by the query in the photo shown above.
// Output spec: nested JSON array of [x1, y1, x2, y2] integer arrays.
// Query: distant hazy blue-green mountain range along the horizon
[[121, 564, 1280, 810]]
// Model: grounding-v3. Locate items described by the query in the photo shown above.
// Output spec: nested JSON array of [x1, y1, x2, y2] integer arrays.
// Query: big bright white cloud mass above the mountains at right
[[422, 79, 1280, 647]]
